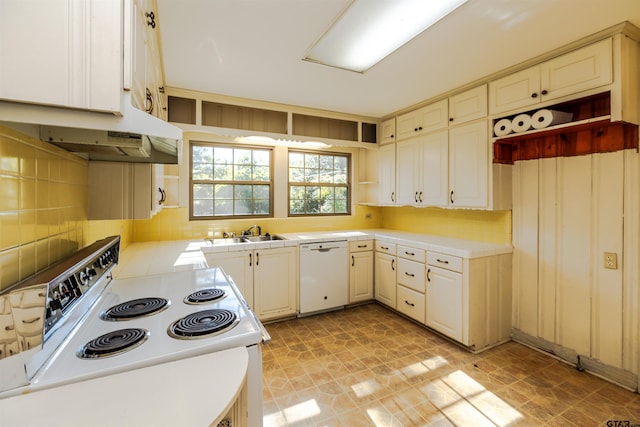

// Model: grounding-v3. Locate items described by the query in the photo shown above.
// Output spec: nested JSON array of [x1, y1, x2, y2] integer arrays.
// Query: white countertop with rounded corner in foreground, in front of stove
[[0, 347, 249, 427]]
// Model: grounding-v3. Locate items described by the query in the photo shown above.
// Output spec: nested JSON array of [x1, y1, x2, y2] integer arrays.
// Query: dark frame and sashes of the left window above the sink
[[189, 141, 275, 221]]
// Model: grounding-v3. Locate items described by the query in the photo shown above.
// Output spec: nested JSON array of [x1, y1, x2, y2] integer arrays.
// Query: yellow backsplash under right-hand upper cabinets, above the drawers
[[382, 207, 511, 244]]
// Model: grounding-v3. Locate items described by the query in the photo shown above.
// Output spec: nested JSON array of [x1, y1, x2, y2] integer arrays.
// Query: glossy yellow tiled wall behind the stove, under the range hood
[[0, 126, 131, 290]]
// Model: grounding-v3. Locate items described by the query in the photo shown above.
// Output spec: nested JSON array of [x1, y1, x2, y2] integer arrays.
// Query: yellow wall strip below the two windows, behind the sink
[[133, 206, 382, 242]]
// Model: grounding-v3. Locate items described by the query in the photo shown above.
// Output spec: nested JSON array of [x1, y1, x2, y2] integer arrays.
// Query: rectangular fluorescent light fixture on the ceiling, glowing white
[[304, 0, 467, 73]]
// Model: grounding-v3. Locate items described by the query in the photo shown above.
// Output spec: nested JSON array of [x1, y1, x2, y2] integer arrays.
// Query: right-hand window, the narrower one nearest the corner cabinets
[[289, 150, 351, 216]]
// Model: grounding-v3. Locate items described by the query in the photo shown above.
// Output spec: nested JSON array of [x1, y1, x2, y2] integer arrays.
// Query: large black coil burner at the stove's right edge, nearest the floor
[[167, 309, 240, 339]]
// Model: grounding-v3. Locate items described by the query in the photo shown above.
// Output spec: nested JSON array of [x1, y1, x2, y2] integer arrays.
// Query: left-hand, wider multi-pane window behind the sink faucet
[[190, 143, 273, 219]]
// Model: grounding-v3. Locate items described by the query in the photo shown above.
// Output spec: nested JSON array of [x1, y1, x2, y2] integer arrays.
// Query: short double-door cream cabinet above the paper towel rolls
[[489, 38, 613, 114]]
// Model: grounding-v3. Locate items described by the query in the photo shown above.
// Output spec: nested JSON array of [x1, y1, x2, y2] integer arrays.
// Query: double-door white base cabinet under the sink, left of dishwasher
[[205, 247, 298, 321]]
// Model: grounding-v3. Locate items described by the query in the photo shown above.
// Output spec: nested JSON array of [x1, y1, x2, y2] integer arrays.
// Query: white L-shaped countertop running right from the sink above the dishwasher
[[278, 229, 513, 258]]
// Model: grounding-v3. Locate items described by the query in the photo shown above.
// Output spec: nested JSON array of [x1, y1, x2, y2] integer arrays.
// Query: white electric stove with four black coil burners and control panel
[[0, 237, 269, 426]]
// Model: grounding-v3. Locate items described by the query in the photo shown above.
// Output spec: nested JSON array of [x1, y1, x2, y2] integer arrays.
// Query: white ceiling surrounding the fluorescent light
[[157, 0, 640, 117]]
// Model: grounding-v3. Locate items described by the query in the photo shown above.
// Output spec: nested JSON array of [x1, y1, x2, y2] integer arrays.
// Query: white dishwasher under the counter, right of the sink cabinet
[[299, 240, 349, 314]]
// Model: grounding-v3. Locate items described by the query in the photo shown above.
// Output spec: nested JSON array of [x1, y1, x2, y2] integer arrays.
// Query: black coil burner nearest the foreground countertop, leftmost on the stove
[[77, 328, 150, 359]]
